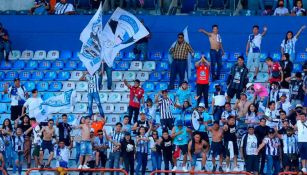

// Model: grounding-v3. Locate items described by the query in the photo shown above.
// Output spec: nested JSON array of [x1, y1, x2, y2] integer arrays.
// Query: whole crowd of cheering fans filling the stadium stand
[[0, 15, 307, 175]]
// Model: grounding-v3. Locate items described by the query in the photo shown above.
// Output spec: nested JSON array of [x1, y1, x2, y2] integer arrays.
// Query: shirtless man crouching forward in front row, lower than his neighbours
[[188, 132, 209, 171]]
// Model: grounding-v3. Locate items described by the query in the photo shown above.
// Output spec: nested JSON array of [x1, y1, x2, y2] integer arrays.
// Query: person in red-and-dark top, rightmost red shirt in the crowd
[[265, 57, 283, 84]]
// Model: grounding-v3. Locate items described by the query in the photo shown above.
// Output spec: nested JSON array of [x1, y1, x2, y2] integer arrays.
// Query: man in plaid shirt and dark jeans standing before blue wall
[[168, 33, 194, 90]]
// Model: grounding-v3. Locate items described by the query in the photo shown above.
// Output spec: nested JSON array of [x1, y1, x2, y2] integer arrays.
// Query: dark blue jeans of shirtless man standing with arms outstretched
[[210, 49, 222, 78]]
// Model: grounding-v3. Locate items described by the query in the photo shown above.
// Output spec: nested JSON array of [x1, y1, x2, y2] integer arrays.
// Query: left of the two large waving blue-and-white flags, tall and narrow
[[79, 3, 102, 75]]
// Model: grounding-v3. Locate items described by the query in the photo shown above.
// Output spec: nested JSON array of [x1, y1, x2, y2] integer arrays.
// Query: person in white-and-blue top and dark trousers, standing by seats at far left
[[4, 78, 28, 120]]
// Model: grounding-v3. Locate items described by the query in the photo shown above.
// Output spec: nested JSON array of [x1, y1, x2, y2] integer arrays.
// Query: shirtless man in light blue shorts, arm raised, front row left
[[78, 116, 92, 169]]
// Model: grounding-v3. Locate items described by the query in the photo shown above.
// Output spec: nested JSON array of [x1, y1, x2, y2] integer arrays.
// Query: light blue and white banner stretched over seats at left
[[35, 90, 76, 122]]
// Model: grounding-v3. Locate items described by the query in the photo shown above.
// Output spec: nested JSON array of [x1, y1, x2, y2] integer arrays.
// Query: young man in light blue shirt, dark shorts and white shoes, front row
[[172, 120, 192, 172]]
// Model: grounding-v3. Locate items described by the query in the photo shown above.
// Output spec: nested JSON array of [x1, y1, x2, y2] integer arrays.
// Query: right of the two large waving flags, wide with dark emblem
[[99, 8, 149, 67]]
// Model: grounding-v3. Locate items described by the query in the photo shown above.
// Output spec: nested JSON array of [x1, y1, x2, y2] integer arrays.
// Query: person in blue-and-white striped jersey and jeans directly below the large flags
[[80, 71, 104, 117]]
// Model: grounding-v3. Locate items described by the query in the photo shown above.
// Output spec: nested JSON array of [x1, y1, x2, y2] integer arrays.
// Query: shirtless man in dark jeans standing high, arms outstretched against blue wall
[[198, 24, 224, 81]]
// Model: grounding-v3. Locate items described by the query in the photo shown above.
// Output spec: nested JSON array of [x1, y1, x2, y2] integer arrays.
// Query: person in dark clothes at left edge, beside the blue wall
[[0, 23, 11, 61]]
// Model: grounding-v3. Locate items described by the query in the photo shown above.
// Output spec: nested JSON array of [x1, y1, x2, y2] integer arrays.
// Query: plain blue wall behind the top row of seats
[[0, 16, 307, 52]]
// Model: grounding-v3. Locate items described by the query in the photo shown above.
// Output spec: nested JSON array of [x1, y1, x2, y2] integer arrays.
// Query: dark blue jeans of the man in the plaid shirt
[[168, 59, 187, 89]]
